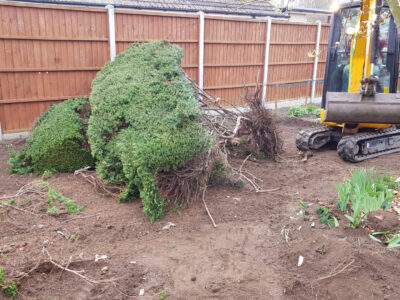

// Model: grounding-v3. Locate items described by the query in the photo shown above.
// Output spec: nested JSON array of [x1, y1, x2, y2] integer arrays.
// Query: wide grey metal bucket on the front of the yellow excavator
[[323, 92, 400, 124]]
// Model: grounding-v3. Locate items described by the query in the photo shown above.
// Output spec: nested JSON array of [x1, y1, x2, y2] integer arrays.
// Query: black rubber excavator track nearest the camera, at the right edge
[[337, 128, 400, 162]]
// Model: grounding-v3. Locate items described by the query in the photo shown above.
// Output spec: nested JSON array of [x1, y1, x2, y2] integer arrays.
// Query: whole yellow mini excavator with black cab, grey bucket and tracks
[[296, 0, 400, 162]]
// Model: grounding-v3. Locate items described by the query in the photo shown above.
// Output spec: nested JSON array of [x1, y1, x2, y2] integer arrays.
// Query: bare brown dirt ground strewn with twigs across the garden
[[0, 112, 400, 300]]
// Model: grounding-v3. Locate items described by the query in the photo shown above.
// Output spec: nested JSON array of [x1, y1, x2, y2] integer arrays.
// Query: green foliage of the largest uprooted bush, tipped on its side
[[88, 41, 210, 221]]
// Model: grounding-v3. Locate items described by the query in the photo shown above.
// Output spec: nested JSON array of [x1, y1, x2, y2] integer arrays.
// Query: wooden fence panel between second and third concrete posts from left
[[204, 17, 266, 105]]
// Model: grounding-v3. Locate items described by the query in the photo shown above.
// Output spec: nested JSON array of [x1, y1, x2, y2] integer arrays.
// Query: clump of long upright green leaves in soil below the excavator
[[336, 169, 395, 228]]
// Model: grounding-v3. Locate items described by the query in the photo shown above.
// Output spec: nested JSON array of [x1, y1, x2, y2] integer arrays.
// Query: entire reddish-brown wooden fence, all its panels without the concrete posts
[[0, 1, 329, 137]]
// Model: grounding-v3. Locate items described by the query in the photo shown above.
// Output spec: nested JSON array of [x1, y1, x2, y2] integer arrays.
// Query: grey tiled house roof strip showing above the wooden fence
[[16, 0, 285, 17]]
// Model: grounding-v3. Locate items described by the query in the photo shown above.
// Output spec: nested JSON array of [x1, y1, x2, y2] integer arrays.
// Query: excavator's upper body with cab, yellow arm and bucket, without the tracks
[[322, 1, 400, 128]]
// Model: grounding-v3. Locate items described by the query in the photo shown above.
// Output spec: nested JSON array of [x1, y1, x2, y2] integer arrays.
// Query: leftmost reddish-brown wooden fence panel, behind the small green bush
[[0, 3, 109, 133]]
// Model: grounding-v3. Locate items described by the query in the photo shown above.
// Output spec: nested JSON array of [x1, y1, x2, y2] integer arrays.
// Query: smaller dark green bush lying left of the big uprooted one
[[8, 98, 94, 176]]
